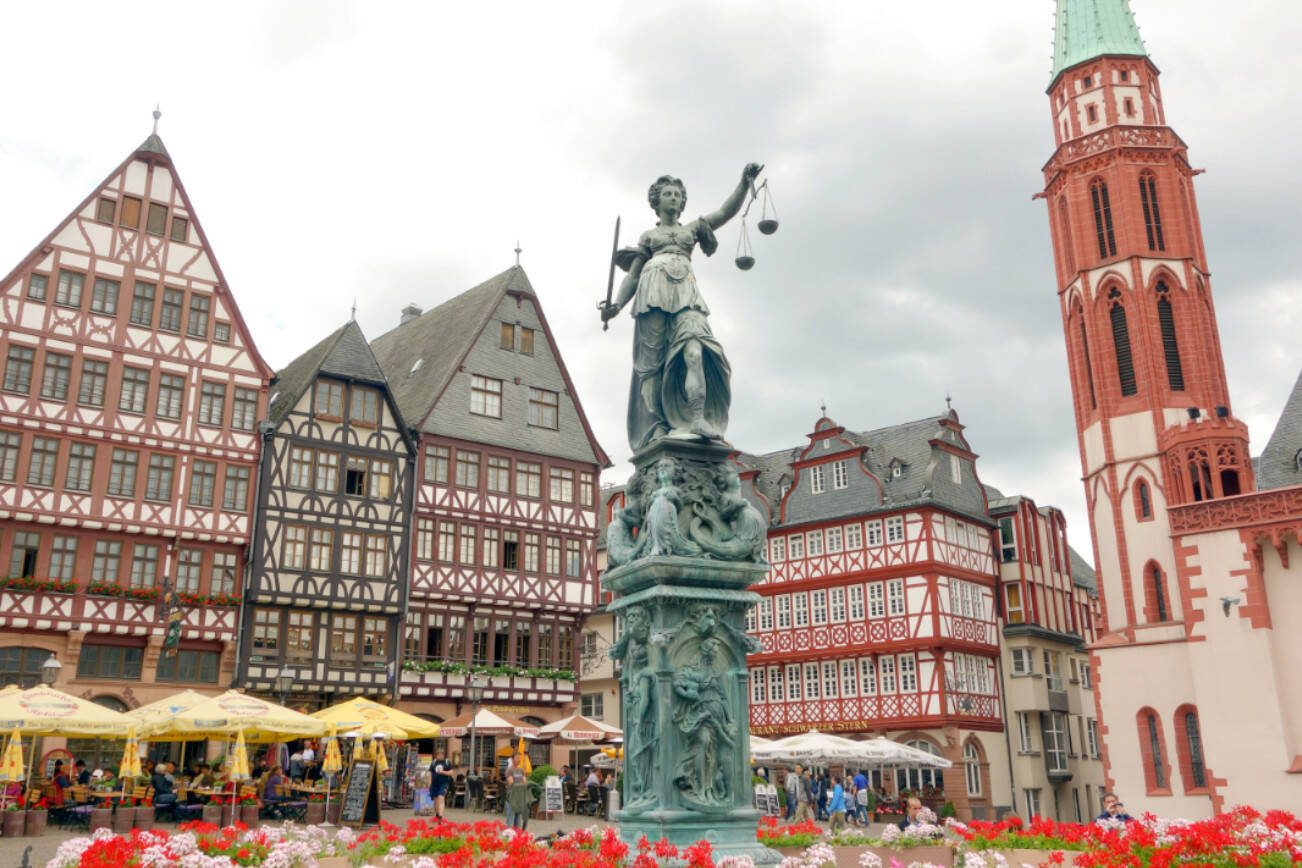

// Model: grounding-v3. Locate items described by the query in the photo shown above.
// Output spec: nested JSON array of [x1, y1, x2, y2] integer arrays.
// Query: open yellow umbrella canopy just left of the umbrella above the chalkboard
[[135, 690, 328, 744]]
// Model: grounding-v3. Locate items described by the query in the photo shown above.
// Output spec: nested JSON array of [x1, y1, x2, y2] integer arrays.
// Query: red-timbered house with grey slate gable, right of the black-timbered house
[[372, 265, 609, 750]]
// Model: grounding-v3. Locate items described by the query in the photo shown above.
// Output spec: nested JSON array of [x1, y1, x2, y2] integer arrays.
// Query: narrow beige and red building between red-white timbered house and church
[[986, 487, 1103, 822]]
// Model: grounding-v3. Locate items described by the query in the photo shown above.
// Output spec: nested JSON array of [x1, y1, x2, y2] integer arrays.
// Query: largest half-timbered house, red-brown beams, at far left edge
[[0, 128, 271, 728]]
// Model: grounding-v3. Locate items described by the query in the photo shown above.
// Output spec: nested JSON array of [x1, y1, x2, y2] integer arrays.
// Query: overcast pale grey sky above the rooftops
[[0, 0, 1302, 557]]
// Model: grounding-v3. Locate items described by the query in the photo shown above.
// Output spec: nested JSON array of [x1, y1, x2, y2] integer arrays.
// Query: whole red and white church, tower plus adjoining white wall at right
[[1042, 0, 1302, 817]]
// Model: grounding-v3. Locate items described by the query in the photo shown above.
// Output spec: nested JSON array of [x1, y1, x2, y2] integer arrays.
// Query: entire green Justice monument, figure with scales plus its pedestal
[[598, 163, 779, 864]]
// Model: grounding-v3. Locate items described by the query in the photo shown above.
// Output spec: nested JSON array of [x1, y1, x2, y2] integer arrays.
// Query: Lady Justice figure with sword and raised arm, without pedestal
[[600, 163, 764, 452]]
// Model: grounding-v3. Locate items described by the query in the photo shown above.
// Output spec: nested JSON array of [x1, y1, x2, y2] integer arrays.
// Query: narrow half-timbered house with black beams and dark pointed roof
[[238, 321, 415, 705]]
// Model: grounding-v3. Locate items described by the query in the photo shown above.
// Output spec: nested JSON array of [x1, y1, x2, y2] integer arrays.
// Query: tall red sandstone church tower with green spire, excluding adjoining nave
[[1042, 0, 1275, 812]]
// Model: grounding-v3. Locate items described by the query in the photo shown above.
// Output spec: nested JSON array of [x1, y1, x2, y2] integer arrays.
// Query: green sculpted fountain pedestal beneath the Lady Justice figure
[[602, 440, 780, 864]]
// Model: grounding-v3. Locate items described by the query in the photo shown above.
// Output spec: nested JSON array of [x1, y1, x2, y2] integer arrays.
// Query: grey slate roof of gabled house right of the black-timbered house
[[371, 265, 611, 467]]
